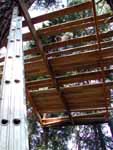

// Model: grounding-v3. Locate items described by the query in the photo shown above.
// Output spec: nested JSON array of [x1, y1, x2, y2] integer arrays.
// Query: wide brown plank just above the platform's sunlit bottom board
[[31, 82, 113, 113]]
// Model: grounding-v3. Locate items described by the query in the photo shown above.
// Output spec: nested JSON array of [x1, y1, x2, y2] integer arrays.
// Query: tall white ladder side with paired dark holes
[[0, 7, 29, 150]]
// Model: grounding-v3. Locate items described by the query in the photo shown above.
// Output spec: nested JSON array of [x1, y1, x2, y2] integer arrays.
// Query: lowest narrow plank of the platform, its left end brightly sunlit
[[42, 111, 106, 126]]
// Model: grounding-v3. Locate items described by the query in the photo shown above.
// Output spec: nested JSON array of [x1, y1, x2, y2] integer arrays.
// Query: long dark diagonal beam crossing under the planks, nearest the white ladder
[[18, 0, 73, 123]]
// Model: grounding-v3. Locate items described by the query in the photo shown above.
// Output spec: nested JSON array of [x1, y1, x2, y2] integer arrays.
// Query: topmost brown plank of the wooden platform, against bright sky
[[23, 1, 92, 26]]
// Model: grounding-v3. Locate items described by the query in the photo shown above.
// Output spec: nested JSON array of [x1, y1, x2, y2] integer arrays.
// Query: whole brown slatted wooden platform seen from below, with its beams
[[0, 0, 113, 127]]
